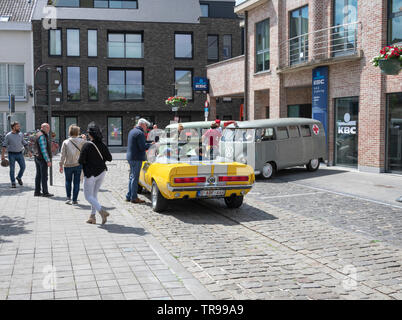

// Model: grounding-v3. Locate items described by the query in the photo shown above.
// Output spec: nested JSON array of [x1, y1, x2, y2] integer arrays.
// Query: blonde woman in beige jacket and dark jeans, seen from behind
[[59, 124, 85, 205]]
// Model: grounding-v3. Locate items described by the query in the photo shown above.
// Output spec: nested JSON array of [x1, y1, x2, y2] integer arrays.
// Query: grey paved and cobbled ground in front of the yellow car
[[0, 156, 402, 299]]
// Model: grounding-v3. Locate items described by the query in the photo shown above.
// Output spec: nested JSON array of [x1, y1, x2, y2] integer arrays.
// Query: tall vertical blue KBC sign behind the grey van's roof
[[312, 67, 328, 137]]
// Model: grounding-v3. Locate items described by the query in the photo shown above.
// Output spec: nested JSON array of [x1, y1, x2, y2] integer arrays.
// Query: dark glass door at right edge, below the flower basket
[[387, 93, 402, 173]]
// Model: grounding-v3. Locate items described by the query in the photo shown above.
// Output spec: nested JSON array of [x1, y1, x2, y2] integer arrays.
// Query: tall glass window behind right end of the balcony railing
[[332, 0, 357, 56]]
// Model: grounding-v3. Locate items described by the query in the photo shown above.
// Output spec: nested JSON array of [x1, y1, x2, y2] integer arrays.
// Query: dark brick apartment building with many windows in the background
[[33, 0, 242, 146]]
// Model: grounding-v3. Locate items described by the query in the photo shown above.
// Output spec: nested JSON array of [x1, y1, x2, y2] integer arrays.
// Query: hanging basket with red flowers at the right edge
[[371, 46, 402, 75]]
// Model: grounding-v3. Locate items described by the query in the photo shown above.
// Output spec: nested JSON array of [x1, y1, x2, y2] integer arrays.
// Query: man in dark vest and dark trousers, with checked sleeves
[[34, 123, 53, 197]]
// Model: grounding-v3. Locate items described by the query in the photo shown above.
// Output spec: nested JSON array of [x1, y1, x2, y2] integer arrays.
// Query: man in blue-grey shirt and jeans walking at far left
[[1, 121, 32, 188]]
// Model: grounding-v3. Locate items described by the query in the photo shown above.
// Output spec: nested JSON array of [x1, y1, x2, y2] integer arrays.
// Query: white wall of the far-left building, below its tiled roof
[[0, 22, 35, 133]]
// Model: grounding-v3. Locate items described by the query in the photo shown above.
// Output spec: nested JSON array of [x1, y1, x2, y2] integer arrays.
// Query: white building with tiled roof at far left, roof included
[[0, 0, 35, 134]]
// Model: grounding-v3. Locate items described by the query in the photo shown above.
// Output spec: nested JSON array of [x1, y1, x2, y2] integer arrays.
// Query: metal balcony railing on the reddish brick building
[[280, 22, 361, 68]]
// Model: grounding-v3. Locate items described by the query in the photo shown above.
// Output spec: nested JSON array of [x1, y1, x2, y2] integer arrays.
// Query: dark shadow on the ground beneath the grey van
[[256, 167, 349, 183]]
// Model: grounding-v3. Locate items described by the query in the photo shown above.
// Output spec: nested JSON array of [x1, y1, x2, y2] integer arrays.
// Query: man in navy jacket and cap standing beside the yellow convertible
[[126, 119, 154, 203]]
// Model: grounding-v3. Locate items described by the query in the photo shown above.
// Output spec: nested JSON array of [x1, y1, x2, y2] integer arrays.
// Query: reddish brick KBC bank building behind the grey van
[[207, 0, 402, 172]]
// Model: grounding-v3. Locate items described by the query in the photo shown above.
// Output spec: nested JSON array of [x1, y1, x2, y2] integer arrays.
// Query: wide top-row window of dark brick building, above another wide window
[[108, 33, 144, 58]]
